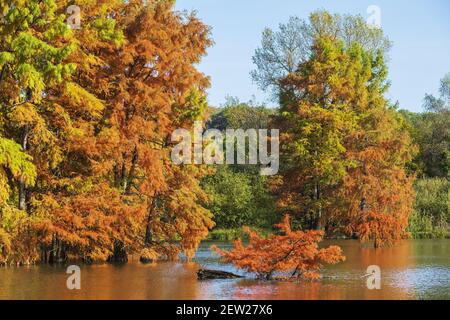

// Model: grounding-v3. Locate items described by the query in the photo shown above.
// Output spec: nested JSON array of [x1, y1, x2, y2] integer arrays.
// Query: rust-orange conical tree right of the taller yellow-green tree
[[331, 48, 416, 247]]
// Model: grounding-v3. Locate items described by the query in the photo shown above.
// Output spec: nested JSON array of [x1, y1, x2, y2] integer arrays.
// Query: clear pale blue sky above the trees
[[176, 0, 450, 111]]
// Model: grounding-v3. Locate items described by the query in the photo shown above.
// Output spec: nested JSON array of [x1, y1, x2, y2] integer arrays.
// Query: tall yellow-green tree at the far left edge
[[0, 0, 86, 263]]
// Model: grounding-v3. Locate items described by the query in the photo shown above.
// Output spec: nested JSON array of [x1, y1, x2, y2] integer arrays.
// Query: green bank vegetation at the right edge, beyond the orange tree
[[400, 75, 450, 238]]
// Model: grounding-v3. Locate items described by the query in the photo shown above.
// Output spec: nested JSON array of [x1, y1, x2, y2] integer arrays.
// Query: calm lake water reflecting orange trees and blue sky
[[0, 240, 450, 300]]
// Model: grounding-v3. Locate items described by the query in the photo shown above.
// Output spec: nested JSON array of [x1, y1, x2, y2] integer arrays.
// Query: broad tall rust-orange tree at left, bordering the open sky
[[42, 1, 216, 261]]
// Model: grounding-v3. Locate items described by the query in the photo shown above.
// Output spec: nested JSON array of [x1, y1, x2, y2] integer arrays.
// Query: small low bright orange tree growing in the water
[[212, 216, 345, 280]]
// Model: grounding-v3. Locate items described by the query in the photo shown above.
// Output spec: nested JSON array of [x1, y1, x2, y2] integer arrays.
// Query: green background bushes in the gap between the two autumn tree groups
[[202, 98, 275, 228]]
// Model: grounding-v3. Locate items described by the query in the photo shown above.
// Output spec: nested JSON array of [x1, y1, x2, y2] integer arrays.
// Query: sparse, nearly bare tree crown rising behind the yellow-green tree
[[251, 10, 391, 100]]
